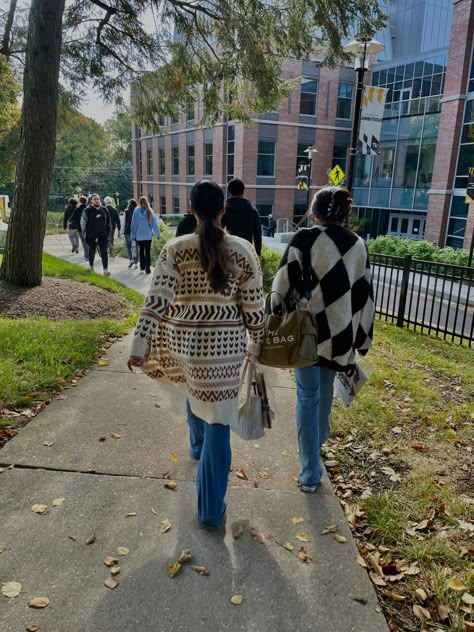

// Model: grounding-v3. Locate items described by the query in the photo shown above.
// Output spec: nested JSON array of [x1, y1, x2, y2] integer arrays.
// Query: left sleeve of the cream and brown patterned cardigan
[[130, 244, 180, 358]]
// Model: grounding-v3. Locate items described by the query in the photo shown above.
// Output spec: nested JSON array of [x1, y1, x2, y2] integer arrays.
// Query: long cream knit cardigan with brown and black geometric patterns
[[130, 234, 264, 425]]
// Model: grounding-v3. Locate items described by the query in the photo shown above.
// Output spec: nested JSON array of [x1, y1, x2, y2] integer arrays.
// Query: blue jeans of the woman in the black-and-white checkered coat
[[295, 366, 336, 485]]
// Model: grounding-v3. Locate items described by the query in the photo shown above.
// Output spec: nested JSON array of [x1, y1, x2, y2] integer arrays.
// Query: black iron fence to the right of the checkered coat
[[370, 253, 474, 347]]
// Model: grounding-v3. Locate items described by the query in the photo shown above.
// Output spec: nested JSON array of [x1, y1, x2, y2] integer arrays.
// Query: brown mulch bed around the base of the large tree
[[0, 277, 130, 320]]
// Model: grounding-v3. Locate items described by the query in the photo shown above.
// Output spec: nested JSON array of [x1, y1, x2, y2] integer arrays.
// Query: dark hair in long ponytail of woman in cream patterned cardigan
[[191, 180, 232, 293]]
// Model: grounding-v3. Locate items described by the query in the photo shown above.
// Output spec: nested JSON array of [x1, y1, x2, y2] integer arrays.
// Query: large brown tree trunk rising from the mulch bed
[[0, 0, 65, 287]]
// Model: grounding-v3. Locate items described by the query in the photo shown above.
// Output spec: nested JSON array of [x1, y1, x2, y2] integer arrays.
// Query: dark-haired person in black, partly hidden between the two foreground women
[[222, 178, 262, 256]]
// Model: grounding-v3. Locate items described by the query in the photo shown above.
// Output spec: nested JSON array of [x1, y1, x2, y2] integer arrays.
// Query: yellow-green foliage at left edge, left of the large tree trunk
[[0, 54, 20, 188]]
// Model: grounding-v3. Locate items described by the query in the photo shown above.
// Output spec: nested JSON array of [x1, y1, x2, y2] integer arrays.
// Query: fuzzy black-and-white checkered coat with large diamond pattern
[[272, 224, 374, 371]]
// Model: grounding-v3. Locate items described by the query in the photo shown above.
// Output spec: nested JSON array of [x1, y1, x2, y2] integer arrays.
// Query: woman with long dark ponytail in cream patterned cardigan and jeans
[[128, 181, 264, 528]]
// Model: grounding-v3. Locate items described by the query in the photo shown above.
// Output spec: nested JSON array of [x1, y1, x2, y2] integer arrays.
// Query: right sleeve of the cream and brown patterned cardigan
[[239, 248, 265, 355]]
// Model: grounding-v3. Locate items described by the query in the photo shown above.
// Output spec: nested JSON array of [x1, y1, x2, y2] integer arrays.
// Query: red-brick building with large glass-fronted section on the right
[[133, 0, 474, 252]]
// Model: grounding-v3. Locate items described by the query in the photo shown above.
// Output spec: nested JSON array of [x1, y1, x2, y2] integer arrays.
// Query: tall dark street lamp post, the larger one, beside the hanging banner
[[343, 37, 385, 191]]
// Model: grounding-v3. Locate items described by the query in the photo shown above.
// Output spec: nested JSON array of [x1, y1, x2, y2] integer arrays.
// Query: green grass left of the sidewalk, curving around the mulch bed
[[0, 254, 143, 410]]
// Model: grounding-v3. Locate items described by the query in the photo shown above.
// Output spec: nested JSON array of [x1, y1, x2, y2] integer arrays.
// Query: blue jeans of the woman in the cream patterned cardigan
[[186, 401, 232, 528]]
